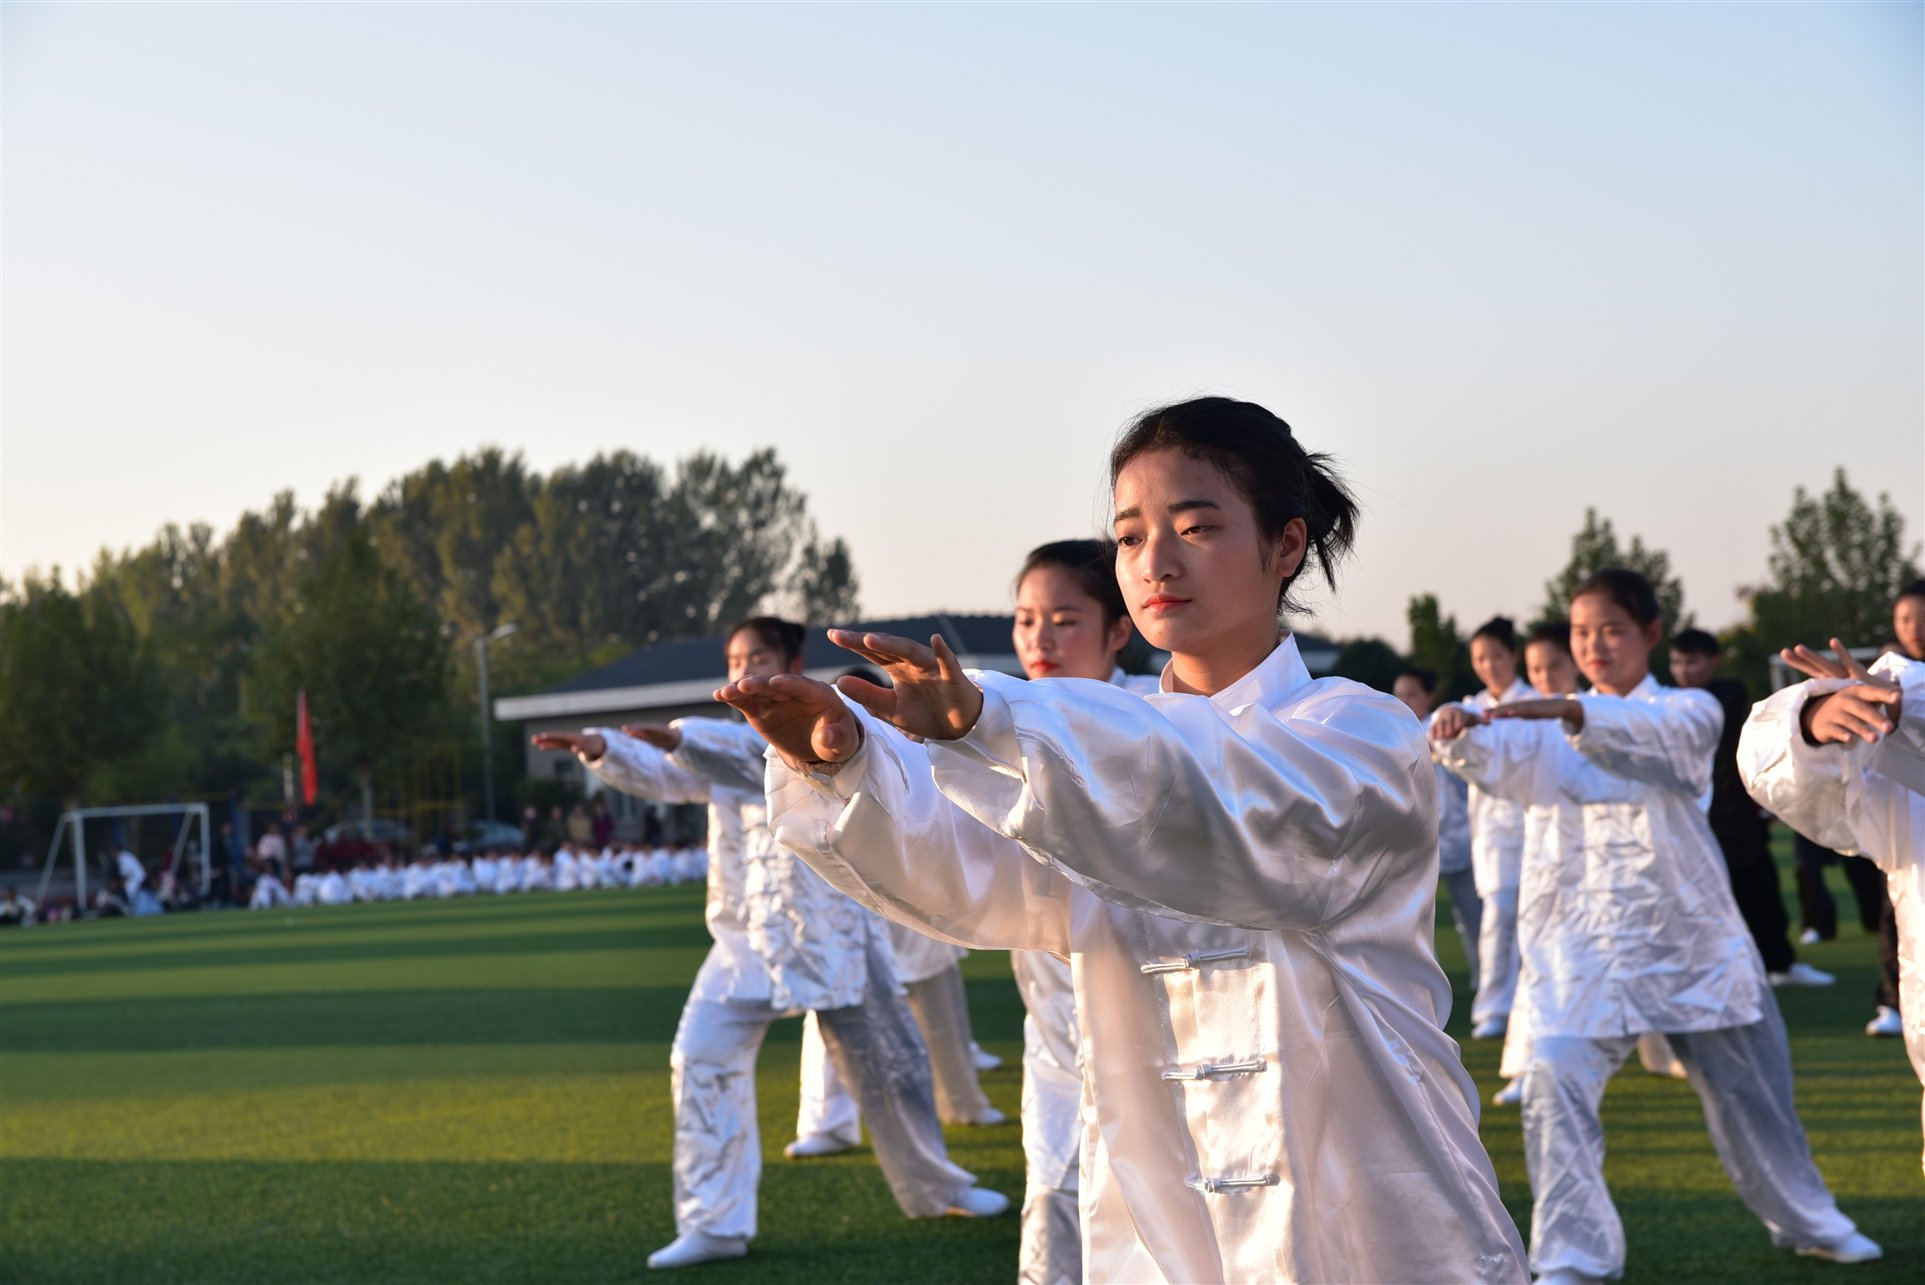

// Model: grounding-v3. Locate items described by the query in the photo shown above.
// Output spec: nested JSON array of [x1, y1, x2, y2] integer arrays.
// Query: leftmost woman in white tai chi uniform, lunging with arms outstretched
[[535, 617, 1009, 1268]]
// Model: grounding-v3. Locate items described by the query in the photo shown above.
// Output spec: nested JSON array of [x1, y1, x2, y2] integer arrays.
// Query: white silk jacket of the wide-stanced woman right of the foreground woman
[[1438, 675, 1765, 1037]]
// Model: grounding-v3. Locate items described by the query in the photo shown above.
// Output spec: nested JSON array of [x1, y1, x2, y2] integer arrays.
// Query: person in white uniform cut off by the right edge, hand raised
[[1738, 627, 1925, 1169]]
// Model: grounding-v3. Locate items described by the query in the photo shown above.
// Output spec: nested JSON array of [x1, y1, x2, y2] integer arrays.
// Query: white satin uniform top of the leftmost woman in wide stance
[[583, 718, 886, 1012]]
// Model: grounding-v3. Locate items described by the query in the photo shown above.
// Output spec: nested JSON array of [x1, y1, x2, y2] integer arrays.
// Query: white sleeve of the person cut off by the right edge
[[1738, 679, 1925, 871]]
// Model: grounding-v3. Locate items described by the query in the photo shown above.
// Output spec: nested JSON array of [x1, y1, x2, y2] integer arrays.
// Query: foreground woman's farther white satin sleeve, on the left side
[[768, 706, 1070, 956]]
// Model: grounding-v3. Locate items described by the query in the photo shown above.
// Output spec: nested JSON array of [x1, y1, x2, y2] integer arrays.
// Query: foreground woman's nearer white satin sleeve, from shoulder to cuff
[[930, 673, 1438, 931]]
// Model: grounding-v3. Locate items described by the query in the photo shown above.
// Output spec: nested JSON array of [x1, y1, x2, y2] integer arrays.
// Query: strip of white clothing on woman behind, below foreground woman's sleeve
[[1009, 950, 1082, 1285]]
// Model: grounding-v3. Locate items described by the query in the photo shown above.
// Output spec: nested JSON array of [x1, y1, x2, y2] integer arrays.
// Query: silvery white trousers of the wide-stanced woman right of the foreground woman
[[1525, 1000, 1856, 1277]]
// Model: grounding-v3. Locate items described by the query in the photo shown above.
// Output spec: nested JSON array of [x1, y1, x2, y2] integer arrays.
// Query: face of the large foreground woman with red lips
[[1115, 450, 1303, 662]]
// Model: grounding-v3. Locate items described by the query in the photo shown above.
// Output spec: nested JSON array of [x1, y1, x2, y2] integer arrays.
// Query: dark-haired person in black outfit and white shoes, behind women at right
[[1671, 629, 1836, 987]]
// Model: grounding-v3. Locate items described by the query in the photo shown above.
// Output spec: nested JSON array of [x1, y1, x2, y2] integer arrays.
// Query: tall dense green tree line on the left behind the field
[[0, 448, 857, 861]]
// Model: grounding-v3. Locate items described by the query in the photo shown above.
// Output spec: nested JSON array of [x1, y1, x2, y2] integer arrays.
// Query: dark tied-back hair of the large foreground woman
[[1109, 396, 1357, 612]]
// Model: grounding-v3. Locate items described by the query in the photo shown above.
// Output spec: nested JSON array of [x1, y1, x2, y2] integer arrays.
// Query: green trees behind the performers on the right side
[[1336, 469, 1919, 700]]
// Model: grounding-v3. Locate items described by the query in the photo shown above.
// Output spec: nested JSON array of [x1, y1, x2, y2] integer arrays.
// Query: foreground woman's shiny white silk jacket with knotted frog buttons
[[768, 639, 1525, 1281]]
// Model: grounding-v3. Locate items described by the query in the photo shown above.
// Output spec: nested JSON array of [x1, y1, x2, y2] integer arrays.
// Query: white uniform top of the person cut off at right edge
[[1738, 656, 1925, 1081]]
